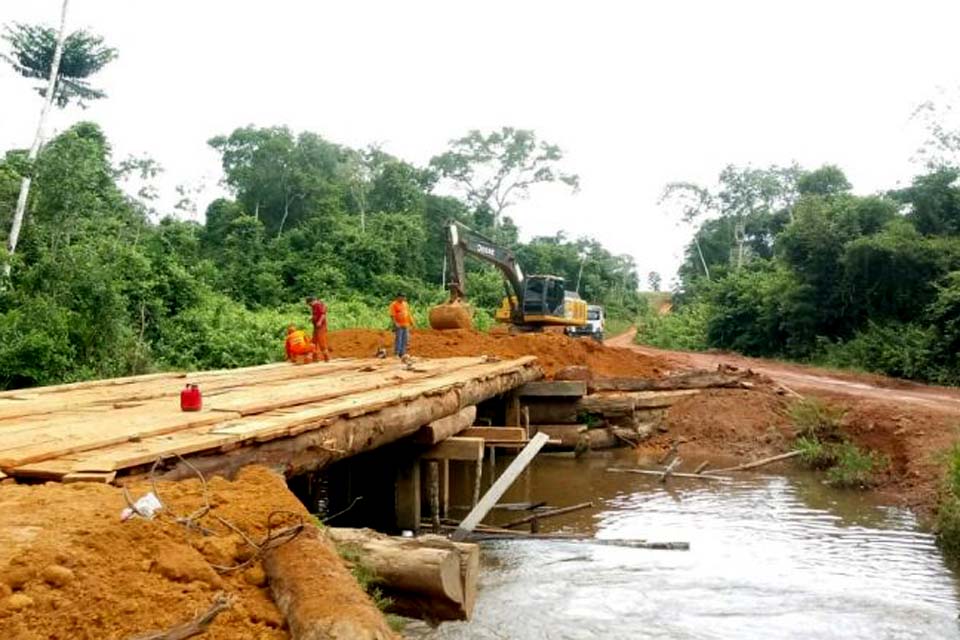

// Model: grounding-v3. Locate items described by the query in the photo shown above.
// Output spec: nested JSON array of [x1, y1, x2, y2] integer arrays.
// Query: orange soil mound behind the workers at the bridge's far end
[[330, 329, 668, 378]]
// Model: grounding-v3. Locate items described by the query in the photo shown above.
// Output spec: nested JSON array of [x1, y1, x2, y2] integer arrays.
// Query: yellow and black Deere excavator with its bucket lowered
[[430, 221, 587, 331]]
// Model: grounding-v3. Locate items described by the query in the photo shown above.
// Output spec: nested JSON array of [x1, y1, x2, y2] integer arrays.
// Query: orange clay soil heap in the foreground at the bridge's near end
[[0, 467, 390, 640]]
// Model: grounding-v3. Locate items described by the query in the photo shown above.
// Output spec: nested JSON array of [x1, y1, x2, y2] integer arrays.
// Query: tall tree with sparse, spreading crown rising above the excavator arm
[[430, 127, 579, 229]]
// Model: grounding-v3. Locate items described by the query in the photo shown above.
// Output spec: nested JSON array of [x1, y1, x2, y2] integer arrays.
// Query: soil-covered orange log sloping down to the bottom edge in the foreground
[[263, 527, 397, 640]]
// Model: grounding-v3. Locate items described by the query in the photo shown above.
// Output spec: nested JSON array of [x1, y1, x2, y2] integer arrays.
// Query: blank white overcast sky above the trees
[[0, 0, 960, 282]]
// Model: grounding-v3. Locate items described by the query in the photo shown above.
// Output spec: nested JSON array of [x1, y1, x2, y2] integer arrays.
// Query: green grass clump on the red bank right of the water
[[788, 398, 884, 489]]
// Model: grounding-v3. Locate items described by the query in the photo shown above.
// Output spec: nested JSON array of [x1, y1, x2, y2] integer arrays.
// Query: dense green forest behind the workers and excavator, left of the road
[[0, 122, 640, 387]]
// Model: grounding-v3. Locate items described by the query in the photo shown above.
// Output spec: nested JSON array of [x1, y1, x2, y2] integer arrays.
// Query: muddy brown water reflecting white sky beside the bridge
[[408, 452, 960, 640]]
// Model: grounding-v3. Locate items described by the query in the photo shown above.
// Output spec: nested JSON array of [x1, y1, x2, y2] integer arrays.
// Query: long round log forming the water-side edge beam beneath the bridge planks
[[149, 367, 542, 481]]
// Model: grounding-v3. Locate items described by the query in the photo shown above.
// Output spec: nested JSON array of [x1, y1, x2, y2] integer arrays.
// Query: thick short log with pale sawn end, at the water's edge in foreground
[[325, 527, 480, 621]]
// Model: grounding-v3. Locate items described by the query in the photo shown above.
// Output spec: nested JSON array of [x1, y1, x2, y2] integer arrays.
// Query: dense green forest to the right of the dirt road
[[639, 152, 960, 384]]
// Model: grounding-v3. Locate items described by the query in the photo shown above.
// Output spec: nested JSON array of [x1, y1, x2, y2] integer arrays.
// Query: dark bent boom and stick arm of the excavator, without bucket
[[447, 220, 523, 321]]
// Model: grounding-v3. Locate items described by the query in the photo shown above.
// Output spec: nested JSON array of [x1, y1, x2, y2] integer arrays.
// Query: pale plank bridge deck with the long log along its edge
[[0, 357, 541, 481]]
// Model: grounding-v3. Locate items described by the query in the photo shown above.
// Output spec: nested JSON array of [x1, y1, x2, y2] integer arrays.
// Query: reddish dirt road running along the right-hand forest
[[606, 330, 960, 419]]
